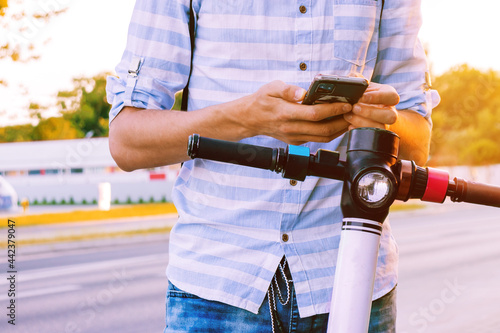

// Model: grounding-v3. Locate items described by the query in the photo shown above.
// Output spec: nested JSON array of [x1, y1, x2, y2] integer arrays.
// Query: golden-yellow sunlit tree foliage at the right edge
[[430, 65, 500, 165]]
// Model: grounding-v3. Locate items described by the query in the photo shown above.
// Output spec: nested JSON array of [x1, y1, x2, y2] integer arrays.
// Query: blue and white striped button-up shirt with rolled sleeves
[[107, 0, 438, 317]]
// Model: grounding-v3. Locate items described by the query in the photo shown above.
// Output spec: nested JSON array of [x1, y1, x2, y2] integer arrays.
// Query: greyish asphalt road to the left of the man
[[0, 237, 168, 333]]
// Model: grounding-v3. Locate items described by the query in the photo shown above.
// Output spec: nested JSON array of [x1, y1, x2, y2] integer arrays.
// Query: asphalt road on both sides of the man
[[0, 205, 500, 333]]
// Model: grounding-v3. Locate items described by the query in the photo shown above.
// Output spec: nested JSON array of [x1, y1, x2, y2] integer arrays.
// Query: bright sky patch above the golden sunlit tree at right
[[420, 0, 500, 75]]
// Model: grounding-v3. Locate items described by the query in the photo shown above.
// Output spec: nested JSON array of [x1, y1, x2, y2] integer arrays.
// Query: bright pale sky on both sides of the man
[[0, 0, 500, 126]]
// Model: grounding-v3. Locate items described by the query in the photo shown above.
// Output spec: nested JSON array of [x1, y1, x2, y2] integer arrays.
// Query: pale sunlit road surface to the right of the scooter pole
[[391, 204, 500, 333]]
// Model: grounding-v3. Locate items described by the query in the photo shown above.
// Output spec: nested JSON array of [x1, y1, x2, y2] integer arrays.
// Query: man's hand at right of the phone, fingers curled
[[344, 82, 399, 130]]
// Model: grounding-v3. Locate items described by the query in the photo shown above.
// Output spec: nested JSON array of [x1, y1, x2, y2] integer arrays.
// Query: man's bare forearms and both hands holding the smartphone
[[109, 81, 430, 171]]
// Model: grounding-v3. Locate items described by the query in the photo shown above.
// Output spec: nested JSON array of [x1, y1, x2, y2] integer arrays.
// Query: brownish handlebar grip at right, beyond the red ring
[[451, 178, 500, 207]]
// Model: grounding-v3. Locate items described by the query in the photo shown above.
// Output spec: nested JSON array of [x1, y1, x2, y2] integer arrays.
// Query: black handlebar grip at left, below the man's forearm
[[188, 134, 277, 171]]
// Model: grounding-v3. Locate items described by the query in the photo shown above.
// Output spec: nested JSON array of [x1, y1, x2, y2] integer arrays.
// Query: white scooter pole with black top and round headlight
[[328, 128, 399, 333]]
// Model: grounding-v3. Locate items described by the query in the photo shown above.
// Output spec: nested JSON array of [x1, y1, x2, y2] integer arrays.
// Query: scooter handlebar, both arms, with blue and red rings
[[188, 134, 500, 207]]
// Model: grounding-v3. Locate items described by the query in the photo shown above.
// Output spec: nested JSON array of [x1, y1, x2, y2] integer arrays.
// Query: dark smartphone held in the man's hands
[[302, 74, 368, 105]]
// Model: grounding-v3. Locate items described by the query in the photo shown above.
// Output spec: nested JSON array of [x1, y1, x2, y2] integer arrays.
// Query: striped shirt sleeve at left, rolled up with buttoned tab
[[106, 0, 191, 122]]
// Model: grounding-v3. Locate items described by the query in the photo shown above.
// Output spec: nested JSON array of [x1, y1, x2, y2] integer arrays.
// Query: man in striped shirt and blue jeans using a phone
[[108, 0, 438, 332]]
